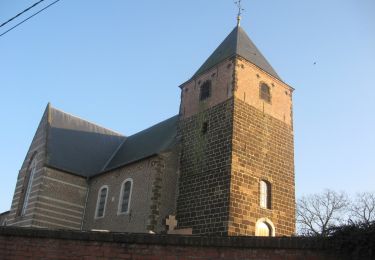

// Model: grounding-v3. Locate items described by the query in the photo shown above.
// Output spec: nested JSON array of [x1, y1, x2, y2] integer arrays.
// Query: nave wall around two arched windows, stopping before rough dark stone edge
[[84, 159, 157, 232]]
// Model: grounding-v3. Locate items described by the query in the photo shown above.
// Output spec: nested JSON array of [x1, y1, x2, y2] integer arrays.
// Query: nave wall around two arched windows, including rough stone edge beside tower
[[84, 154, 178, 232]]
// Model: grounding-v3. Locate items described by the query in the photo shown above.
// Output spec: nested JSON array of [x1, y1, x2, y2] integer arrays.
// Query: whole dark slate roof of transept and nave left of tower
[[47, 105, 178, 177]]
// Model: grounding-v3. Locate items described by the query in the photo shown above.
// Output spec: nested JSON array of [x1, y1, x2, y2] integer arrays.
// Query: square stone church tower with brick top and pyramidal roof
[[177, 26, 295, 236]]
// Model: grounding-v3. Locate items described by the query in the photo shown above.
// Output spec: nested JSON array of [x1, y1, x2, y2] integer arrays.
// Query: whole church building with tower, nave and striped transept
[[6, 20, 295, 236]]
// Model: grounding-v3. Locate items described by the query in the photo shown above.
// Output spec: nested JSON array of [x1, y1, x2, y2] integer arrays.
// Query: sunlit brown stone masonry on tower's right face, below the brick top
[[229, 98, 295, 236]]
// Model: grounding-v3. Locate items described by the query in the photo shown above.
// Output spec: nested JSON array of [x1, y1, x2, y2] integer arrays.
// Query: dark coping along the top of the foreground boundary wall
[[0, 226, 330, 250]]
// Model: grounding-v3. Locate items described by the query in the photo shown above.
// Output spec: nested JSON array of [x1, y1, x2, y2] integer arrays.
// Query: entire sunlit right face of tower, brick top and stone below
[[229, 57, 295, 236]]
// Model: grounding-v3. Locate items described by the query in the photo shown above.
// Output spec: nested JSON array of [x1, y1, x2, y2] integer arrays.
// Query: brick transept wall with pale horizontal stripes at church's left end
[[7, 106, 87, 229]]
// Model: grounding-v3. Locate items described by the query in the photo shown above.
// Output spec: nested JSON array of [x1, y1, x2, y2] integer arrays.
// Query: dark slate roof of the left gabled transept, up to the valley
[[47, 107, 125, 177]]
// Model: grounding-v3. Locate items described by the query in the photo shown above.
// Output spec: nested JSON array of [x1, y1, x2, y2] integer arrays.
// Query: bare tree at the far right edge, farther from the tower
[[350, 192, 375, 224]]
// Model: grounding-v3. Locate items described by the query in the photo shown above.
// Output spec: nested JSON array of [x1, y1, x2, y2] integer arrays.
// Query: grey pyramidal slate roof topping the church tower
[[193, 26, 281, 80]]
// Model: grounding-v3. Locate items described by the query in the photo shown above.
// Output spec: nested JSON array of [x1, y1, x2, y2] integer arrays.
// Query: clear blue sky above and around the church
[[0, 0, 375, 212]]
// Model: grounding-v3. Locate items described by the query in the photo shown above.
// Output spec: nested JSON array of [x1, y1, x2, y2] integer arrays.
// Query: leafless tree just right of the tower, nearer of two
[[296, 190, 349, 236]]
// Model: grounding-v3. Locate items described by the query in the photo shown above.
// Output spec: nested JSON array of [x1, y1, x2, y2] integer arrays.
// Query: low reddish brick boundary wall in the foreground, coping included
[[0, 227, 346, 260]]
